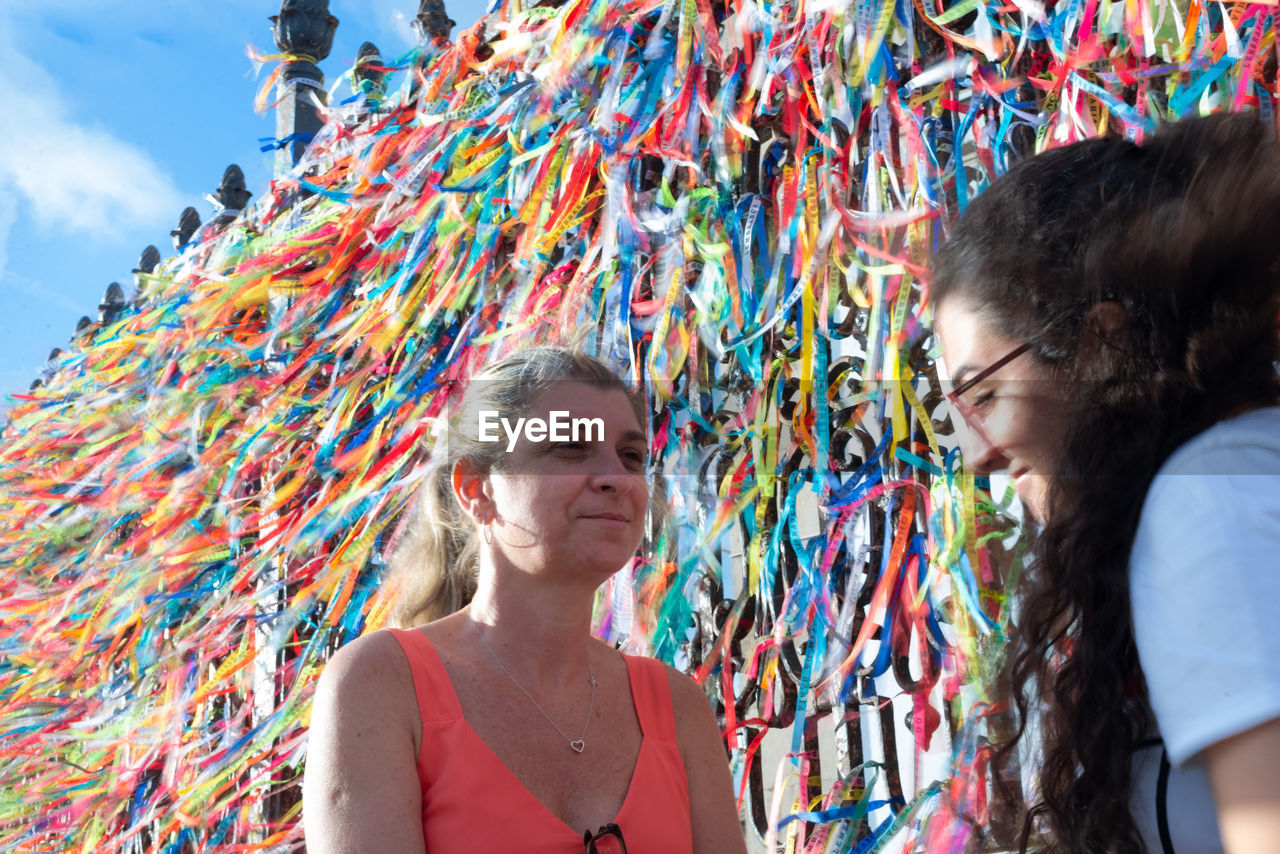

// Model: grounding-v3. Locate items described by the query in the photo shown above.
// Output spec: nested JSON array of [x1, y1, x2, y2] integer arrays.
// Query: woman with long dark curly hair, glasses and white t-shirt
[[932, 114, 1280, 854]]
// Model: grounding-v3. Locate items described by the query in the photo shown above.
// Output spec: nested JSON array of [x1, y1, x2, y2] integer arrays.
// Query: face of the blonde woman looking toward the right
[[471, 382, 649, 584]]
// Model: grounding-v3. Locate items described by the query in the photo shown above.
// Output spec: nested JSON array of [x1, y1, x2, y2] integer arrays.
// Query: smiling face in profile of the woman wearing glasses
[[933, 298, 1071, 522]]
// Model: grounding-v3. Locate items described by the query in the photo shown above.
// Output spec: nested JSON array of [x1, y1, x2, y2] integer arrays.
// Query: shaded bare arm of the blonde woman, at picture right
[[667, 670, 746, 854]]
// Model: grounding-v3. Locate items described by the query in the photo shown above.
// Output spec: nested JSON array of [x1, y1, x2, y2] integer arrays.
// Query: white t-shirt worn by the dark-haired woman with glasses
[[1129, 407, 1280, 854]]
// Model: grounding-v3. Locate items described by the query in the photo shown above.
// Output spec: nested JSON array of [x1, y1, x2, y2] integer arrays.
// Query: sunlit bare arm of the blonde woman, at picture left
[[302, 632, 426, 854]]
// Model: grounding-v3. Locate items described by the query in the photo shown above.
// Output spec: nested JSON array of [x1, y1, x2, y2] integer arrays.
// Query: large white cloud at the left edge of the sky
[[0, 22, 183, 243]]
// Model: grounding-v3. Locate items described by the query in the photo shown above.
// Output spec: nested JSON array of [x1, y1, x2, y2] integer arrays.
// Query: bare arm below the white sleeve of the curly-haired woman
[[1204, 718, 1280, 854]]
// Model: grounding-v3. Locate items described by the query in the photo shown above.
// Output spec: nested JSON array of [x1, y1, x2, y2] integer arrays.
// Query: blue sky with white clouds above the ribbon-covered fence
[[0, 0, 486, 411]]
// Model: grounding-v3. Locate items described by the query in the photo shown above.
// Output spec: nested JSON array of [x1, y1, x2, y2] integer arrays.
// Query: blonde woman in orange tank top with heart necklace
[[303, 348, 745, 854]]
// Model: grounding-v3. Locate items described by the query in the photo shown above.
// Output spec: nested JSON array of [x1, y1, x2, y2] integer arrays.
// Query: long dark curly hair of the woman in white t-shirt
[[931, 114, 1280, 854]]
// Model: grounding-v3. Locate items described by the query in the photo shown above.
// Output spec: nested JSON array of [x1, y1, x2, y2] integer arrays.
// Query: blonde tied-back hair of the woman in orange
[[387, 347, 648, 627]]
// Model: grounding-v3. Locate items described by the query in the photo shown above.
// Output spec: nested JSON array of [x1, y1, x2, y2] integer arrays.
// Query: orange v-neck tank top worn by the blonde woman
[[390, 629, 694, 854]]
